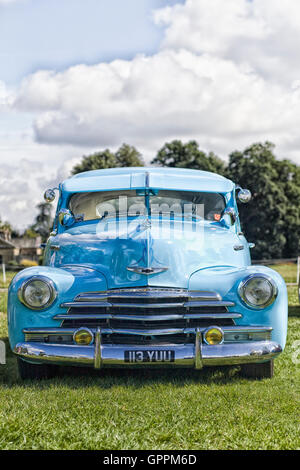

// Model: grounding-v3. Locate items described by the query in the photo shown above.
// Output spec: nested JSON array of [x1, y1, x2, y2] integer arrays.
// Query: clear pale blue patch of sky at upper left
[[0, 0, 181, 85]]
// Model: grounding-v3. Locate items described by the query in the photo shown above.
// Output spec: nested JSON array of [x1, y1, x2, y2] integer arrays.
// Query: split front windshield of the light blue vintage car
[[69, 190, 225, 221]]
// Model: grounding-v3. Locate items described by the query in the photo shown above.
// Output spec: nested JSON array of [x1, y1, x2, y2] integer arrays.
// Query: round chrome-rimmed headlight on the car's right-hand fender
[[239, 274, 277, 309]]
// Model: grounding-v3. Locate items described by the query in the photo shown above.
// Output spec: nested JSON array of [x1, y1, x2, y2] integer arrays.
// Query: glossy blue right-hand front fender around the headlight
[[189, 266, 288, 349]]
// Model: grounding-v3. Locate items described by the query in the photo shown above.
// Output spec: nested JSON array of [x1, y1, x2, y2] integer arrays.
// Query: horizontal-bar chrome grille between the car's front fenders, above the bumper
[[54, 288, 241, 344]]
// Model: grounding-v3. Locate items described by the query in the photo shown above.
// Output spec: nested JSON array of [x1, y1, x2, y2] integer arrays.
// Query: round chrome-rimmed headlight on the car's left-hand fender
[[19, 276, 57, 310]]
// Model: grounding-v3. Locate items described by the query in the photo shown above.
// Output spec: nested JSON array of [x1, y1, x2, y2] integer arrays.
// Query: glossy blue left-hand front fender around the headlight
[[7, 265, 107, 349]]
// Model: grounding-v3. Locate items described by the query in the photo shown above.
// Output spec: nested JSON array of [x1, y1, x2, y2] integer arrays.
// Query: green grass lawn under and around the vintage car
[[0, 266, 300, 450]]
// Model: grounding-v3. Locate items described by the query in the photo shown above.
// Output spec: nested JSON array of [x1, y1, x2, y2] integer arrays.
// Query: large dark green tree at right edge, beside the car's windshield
[[226, 142, 300, 259]]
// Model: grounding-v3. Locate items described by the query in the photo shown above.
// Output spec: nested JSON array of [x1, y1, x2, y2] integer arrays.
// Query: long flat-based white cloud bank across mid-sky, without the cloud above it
[[15, 49, 300, 161]]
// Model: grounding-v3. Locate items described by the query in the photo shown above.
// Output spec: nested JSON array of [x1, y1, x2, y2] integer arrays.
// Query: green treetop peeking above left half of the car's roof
[[72, 144, 143, 175]]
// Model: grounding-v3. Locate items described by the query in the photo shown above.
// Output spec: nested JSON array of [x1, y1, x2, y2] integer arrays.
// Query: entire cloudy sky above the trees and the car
[[0, 0, 300, 229]]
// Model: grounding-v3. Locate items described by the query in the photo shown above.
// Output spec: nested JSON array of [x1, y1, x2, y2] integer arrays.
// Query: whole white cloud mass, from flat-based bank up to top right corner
[[15, 0, 300, 159]]
